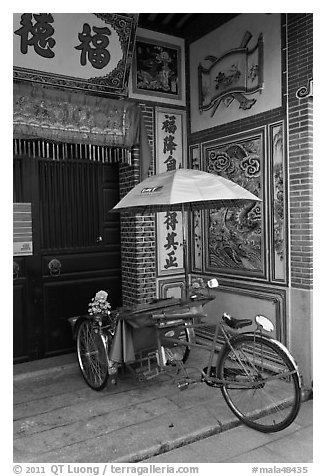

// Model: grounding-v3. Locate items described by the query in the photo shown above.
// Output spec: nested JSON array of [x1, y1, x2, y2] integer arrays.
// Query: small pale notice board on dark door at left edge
[[13, 203, 33, 256]]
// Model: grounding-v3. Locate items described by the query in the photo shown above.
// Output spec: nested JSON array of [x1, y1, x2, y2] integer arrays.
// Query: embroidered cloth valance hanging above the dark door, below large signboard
[[13, 82, 141, 148]]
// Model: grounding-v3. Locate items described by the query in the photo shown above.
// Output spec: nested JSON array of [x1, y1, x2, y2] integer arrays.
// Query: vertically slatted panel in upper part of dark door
[[38, 159, 103, 249]]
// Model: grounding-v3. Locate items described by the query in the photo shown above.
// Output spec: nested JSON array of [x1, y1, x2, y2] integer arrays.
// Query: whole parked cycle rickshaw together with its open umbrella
[[70, 169, 301, 432]]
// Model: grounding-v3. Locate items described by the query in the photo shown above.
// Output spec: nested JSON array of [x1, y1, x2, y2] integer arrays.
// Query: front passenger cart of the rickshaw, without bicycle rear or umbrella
[[69, 296, 212, 390]]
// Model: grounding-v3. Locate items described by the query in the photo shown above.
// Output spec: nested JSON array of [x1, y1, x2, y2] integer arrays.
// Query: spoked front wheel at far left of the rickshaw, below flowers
[[76, 320, 109, 391]]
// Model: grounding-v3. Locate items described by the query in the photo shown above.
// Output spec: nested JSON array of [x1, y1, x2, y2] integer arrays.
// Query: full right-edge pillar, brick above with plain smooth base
[[287, 13, 313, 386]]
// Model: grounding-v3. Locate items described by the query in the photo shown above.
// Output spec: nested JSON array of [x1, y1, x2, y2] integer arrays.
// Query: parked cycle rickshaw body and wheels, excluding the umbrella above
[[71, 280, 301, 432]]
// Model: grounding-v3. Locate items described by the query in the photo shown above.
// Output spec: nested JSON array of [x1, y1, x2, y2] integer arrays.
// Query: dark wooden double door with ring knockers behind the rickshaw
[[14, 139, 121, 362]]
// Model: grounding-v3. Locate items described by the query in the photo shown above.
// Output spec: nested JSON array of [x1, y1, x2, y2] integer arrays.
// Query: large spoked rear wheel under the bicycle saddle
[[217, 334, 301, 433]]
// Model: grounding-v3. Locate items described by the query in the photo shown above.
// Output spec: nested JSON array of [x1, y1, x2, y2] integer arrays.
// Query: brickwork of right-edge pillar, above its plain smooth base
[[287, 13, 313, 289]]
